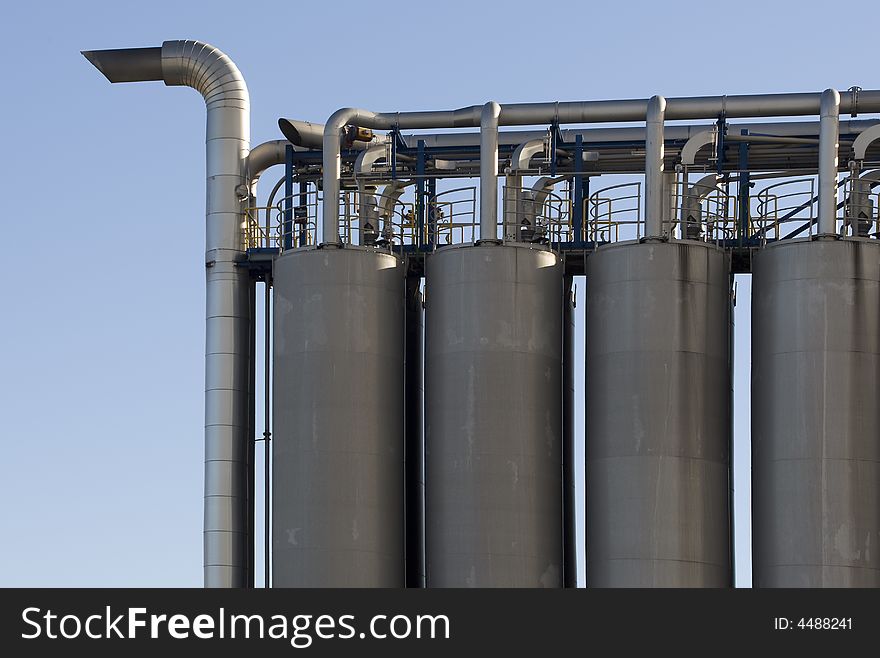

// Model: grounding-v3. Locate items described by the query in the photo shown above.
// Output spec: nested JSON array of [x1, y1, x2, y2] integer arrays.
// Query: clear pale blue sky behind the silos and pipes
[[0, 0, 878, 586]]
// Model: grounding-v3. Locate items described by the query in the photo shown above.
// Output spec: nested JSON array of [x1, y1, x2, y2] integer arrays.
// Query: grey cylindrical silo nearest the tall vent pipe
[[272, 247, 404, 587]]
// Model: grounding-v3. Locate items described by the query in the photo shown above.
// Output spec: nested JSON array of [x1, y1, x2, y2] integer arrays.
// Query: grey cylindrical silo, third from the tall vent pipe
[[585, 240, 732, 587]]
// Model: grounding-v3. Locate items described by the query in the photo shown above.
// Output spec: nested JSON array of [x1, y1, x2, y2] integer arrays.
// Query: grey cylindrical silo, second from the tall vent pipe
[[425, 245, 563, 587]]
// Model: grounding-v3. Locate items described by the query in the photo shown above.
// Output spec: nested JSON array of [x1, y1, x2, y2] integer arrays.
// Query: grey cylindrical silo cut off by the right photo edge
[[752, 238, 880, 587]]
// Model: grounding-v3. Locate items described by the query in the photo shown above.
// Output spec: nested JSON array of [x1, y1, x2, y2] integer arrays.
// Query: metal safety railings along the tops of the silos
[[248, 176, 880, 249]]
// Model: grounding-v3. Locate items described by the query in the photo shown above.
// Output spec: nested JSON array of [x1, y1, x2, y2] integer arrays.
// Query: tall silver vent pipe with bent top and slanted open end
[[83, 39, 253, 587]]
